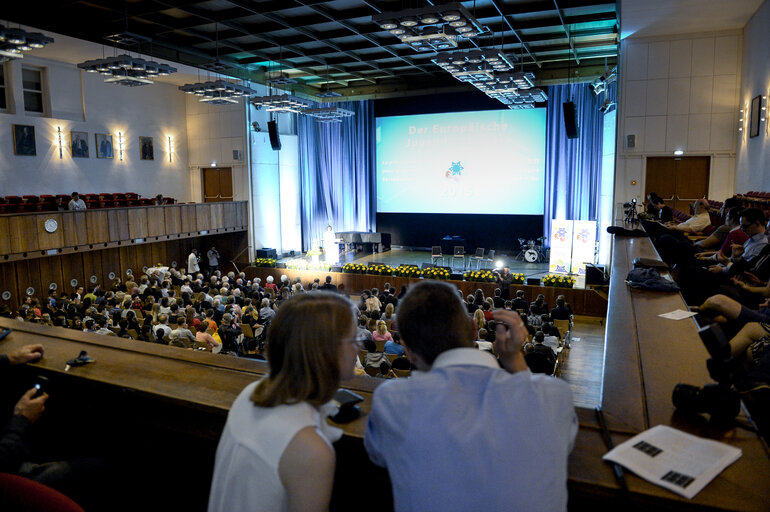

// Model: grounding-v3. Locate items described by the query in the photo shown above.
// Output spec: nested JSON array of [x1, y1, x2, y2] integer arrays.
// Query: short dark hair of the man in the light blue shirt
[[397, 280, 475, 365]]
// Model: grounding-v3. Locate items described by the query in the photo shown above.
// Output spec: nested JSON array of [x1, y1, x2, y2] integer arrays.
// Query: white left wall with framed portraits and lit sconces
[[0, 52, 191, 201]]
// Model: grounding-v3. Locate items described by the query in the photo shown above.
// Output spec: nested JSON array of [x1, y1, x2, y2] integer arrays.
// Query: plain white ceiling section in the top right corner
[[620, 0, 764, 39]]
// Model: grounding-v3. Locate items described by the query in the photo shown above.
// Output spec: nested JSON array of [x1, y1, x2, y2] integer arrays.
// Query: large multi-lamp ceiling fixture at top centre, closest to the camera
[[372, 2, 487, 52]]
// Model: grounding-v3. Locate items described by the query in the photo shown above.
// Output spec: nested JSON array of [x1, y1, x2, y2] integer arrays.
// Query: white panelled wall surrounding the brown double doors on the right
[[615, 31, 742, 208]]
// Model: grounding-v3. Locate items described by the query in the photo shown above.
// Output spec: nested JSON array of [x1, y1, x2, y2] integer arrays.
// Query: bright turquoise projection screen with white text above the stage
[[376, 108, 545, 215]]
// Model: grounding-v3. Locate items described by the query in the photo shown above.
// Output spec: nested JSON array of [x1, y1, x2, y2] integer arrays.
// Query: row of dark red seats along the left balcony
[[0, 192, 176, 214]]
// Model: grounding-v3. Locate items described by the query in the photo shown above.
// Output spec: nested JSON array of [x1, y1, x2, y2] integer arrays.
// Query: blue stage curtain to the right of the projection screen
[[543, 83, 605, 246]]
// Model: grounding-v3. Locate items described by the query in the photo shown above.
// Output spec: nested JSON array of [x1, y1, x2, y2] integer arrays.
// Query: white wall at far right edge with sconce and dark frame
[[735, 1, 770, 193]]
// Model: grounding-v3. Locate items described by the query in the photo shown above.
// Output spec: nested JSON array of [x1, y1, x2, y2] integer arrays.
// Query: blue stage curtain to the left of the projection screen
[[297, 101, 377, 250]]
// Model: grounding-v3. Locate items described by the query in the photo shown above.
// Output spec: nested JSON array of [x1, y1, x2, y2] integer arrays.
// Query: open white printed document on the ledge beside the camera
[[602, 425, 742, 499]]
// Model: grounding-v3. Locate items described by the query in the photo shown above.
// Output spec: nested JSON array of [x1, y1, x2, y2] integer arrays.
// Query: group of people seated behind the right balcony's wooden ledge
[[643, 197, 770, 390]]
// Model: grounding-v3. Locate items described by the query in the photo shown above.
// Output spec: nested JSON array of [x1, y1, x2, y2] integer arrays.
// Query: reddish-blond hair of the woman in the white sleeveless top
[[251, 292, 355, 407]]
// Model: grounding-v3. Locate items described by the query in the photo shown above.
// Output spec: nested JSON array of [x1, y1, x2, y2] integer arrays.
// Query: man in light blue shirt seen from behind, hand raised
[[364, 281, 578, 512]]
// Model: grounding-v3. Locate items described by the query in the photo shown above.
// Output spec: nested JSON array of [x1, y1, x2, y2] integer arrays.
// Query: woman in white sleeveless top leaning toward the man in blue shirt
[[208, 292, 360, 512]]
